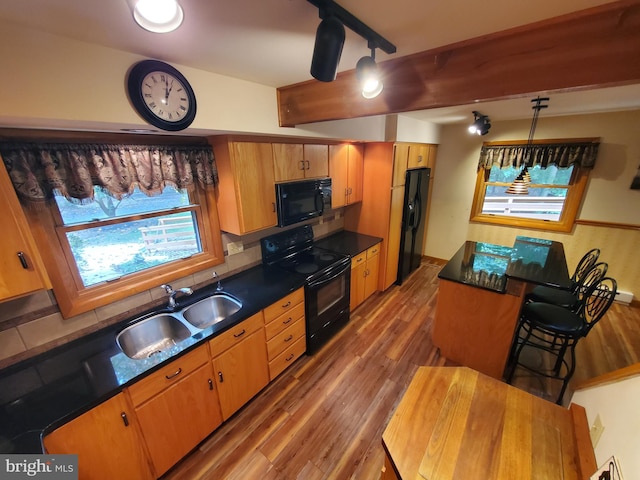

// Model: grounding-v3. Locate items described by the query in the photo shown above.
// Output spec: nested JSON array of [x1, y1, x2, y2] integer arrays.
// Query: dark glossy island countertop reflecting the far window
[[438, 237, 571, 293]]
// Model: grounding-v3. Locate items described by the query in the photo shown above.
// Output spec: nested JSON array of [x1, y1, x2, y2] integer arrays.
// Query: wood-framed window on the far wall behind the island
[[471, 142, 597, 232]]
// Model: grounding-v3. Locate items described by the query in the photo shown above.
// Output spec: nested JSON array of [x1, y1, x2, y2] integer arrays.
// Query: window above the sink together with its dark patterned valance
[[0, 141, 224, 317]]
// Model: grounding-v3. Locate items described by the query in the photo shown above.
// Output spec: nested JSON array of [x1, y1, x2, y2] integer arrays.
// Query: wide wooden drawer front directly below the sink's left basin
[[129, 347, 209, 407]]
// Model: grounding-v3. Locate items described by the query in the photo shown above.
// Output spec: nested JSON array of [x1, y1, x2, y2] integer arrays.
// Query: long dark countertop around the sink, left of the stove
[[0, 265, 305, 453]]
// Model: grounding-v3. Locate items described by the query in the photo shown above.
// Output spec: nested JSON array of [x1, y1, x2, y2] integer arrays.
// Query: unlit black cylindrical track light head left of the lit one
[[311, 15, 345, 82]]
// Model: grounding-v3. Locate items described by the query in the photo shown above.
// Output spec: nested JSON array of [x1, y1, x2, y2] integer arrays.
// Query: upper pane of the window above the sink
[[55, 187, 190, 225]]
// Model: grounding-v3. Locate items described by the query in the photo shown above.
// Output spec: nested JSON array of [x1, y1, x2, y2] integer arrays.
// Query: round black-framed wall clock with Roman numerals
[[127, 60, 196, 132]]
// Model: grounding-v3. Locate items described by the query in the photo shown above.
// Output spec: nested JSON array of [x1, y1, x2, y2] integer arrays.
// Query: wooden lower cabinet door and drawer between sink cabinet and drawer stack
[[210, 312, 269, 420]]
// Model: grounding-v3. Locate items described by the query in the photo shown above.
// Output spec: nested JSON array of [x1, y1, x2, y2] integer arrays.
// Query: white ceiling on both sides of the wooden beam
[[0, 0, 640, 123]]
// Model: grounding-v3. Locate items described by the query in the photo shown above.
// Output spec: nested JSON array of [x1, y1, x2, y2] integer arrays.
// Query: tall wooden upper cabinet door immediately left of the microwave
[[232, 142, 277, 233]]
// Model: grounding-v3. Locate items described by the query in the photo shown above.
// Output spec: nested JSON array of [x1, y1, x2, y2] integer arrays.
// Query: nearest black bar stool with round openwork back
[[506, 277, 618, 405]]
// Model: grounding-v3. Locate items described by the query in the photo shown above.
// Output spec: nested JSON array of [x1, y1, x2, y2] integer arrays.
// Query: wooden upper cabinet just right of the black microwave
[[329, 144, 364, 208]]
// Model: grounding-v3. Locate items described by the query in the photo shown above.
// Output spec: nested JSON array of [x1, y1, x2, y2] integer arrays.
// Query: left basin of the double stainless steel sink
[[116, 313, 192, 360]]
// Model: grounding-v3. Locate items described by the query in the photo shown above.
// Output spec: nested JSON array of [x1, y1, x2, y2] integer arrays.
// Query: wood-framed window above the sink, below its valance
[[26, 186, 224, 317]]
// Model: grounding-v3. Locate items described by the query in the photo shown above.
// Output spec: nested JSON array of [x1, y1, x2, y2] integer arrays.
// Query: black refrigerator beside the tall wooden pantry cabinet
[[396, 168, 431, 285]]
